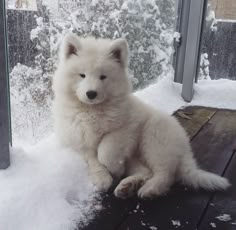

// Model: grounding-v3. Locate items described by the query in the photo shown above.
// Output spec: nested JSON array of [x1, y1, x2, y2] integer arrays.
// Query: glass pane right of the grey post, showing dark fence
[[199, 0, 236, 80]]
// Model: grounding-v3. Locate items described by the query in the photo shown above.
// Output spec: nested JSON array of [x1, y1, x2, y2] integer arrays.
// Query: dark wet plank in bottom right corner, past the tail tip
[[198, 150, 236, 230]]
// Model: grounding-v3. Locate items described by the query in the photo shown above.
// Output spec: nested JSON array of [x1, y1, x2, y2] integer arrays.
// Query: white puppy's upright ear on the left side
[[60, 33, 80, 60]]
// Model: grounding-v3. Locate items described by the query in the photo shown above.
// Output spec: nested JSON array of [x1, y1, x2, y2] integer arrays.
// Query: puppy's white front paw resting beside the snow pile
[[92, 171, 113, 192]]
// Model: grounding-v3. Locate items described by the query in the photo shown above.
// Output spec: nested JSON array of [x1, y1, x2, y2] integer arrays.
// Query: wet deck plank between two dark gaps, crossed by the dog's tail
[[119, 111, 236, 230]]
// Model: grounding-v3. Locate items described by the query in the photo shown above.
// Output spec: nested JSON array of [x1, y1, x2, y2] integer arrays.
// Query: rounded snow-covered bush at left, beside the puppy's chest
[[10, 64, 52, 143]]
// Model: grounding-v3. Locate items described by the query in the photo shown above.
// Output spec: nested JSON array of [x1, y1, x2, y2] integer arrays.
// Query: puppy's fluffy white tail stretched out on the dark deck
[[180, 154, 230, 190]]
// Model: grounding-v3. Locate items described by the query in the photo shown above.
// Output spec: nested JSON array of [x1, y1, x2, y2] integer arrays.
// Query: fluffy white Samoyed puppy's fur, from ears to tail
[[53, 34, 229, 198]]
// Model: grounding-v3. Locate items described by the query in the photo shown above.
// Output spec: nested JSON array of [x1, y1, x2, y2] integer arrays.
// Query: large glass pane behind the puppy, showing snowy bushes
[[7, 0, 175, 142]]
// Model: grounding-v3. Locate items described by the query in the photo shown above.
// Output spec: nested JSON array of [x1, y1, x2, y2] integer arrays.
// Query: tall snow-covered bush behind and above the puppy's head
[[31, 0, 174, 89]]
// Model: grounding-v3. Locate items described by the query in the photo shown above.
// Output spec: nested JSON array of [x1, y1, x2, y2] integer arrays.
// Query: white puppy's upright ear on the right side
[[109, 38, 129, 67]]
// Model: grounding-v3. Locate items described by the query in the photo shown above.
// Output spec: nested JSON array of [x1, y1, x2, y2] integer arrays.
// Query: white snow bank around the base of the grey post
[[136, 76, 236, 114]]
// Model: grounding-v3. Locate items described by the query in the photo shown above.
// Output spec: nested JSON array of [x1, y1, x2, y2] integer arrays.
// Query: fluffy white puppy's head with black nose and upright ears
[[54, 34, 131, 104]]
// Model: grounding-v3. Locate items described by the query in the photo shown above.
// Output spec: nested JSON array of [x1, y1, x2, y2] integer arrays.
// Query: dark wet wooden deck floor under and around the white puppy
[[79, 107, 236, 230]]
